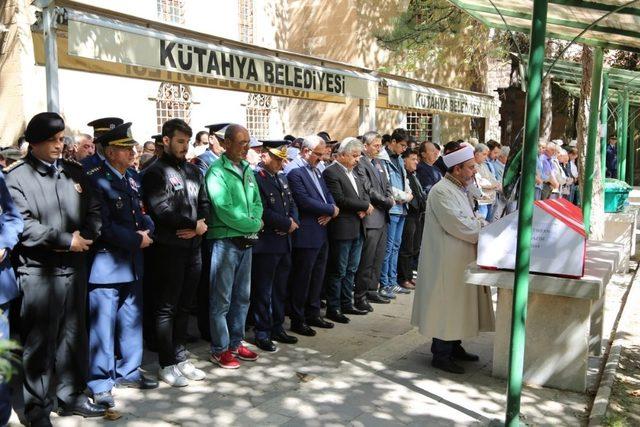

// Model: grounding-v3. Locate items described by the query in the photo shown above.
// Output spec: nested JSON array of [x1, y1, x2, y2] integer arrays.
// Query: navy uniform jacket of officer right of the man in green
[[253, 165, 300, 254]]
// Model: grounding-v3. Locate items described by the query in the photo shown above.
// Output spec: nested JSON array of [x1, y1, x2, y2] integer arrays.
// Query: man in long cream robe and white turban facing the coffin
[[411, 145, 494, 374]]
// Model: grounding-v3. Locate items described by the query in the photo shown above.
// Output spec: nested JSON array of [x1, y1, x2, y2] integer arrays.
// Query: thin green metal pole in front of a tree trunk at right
[[582, 47, 603, 239]]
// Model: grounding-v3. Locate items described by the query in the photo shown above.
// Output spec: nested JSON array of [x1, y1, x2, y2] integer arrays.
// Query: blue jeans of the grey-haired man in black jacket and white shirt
[[327, 235, 364, 311]]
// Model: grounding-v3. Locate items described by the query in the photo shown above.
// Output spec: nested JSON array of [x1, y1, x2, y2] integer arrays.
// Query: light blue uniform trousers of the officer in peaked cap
[[87, 282, 142, 393]]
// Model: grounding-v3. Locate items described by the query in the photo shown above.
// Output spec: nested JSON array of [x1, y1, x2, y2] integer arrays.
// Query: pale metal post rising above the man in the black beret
[[42, 1, 60, 113]]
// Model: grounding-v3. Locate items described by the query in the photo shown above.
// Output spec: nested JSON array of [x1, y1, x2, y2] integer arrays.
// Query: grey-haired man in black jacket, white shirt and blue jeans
[[322, 138, 373, 323]]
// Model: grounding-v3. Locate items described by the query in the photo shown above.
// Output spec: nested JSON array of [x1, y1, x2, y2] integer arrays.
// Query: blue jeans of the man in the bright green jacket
[[209, 239, 252, 354]]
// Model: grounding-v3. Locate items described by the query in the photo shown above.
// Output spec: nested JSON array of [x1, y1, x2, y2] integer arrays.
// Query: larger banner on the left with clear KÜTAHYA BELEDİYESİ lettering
[[68, 21, 378, 99]]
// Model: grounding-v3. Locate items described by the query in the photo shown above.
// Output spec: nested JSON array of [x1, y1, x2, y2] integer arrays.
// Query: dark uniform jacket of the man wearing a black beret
[[5, 153, 102, 275]]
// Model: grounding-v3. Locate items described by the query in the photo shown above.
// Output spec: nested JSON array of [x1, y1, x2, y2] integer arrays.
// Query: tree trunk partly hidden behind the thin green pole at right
[[576, 46, 604, 240]]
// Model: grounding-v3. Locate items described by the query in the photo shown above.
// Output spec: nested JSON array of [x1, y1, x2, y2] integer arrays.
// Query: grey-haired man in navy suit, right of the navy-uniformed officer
[[287, 135, 340, 336]]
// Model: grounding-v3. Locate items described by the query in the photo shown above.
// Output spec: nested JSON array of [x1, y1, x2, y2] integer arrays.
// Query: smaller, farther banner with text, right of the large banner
[[387, 81, 497, 117]]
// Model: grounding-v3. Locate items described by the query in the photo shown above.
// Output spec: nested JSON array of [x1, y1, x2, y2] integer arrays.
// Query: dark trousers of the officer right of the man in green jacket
[[250, 252, 291, 339]]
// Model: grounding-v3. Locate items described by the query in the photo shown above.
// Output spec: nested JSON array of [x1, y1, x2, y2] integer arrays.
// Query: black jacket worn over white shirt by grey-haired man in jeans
[[322, 162, 369, 240]]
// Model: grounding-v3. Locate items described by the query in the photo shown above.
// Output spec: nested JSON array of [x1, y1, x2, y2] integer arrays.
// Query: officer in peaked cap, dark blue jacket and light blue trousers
[[87, 123, 158, 407]]
